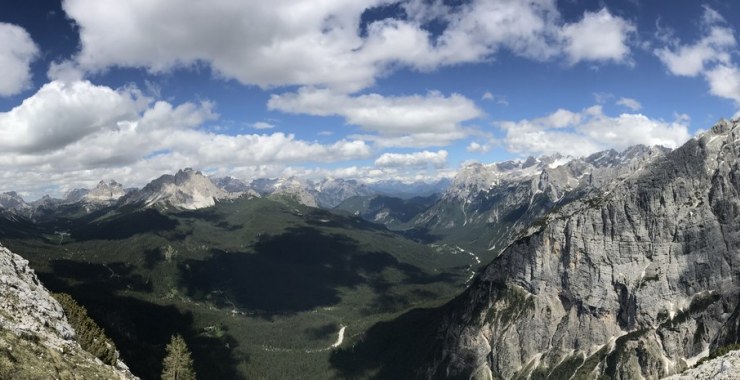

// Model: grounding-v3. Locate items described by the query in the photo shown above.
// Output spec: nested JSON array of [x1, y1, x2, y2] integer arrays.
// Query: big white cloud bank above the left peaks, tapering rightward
[[0, 81, 373, 196]]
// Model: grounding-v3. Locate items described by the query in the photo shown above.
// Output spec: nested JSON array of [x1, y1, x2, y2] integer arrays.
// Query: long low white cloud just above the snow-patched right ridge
[[496, 106, 690, 156]]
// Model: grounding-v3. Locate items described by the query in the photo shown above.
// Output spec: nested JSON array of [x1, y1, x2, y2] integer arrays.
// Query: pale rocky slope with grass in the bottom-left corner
[[0, 245, 136, 379]]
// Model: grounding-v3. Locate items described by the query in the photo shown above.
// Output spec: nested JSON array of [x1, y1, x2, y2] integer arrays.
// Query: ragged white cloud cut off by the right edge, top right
[[654, 6, 740, 104]]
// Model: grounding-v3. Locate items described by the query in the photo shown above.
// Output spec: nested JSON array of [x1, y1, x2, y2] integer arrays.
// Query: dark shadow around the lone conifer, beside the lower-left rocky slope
[[38, 270, 249, 379]]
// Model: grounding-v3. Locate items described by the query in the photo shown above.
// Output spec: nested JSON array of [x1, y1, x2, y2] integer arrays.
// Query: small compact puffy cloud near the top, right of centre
[[561, 8, 637, 63]]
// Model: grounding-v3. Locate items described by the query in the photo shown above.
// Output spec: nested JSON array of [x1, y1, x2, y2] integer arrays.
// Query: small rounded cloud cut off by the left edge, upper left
[[0, 22, 39, 96]]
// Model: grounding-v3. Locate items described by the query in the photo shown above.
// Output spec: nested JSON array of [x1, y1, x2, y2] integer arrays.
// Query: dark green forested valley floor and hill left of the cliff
[[0, 199, 471, 379]]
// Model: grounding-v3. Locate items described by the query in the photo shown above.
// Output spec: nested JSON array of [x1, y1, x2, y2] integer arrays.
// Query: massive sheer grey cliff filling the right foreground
[[426, 120, 740, 379]]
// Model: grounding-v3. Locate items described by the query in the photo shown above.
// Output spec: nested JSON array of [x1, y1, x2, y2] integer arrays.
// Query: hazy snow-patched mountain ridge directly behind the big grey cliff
[[414, 145, 668, 257]]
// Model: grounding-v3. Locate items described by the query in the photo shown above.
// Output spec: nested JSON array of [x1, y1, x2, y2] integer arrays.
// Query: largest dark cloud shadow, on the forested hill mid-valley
[[180, 227, 454, 315]]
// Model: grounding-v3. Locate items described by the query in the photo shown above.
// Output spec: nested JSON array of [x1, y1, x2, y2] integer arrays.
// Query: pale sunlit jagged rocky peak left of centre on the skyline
[[120, 168, 235, 210]]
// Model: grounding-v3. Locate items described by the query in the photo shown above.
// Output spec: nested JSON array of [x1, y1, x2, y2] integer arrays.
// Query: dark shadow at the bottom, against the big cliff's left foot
[[330, 308, 442, 379]]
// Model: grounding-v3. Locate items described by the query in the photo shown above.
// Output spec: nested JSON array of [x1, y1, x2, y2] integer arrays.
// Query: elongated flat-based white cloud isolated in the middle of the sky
[[268, 87, 482, 147]]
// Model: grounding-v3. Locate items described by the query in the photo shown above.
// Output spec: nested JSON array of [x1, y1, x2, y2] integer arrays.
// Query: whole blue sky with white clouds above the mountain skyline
[[0, 0, 740, 200]]
